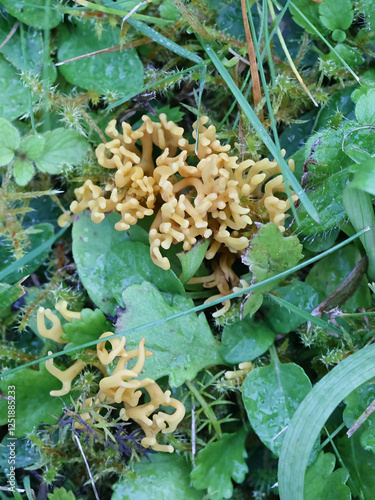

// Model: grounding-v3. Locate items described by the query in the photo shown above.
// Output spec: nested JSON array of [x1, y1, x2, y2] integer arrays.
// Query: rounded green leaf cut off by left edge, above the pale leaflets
[[0, 54, 29, 121]]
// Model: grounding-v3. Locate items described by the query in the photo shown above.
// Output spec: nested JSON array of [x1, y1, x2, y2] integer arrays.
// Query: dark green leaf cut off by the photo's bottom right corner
[[336, 429, 375, 500]]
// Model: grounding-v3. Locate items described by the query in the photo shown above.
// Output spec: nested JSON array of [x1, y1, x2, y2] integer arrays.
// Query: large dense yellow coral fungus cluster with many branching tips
[[70, 114, 297, 314]]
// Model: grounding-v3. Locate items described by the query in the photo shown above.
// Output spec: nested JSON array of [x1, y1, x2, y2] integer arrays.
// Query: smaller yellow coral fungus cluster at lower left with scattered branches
[[37, 301, 185, 453]]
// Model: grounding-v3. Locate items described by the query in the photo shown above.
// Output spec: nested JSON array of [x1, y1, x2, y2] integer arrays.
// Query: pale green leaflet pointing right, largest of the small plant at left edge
[[35, 128, 88, 174]]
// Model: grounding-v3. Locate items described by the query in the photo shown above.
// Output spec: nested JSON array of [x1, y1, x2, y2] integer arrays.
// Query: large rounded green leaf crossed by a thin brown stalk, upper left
[[58, 23, 143, 96]]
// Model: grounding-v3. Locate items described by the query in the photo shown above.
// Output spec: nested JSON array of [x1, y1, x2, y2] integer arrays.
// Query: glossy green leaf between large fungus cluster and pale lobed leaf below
[[105, 241, 185, 306]]
